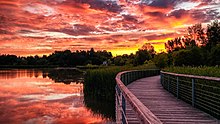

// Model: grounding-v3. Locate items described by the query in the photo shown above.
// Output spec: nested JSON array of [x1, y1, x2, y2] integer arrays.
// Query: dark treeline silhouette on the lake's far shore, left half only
[[0, 48, 112, 67]]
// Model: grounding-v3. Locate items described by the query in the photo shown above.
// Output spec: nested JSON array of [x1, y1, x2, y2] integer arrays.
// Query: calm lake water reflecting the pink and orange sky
[[0, 69, 112, 124]]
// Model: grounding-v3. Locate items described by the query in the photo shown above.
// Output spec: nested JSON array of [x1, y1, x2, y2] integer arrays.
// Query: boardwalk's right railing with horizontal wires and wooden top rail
[[161, 71, 220, 119]]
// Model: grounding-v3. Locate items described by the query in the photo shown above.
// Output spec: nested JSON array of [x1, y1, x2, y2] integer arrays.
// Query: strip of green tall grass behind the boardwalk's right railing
[[163, 66, 220, 77]]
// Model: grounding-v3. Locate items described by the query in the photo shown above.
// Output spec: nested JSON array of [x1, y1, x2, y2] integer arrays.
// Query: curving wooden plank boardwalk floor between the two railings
[[126, 76, 220, 124]]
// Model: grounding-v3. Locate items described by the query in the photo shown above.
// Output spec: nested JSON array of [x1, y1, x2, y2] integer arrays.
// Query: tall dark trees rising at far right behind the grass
[[153, 20, 220, 68]]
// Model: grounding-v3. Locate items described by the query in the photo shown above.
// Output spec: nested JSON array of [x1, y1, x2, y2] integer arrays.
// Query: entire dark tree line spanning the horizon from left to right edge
[[0, 20, 220, 68]]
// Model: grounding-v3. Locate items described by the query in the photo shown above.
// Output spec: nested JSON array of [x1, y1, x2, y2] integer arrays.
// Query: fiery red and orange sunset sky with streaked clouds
[[0, 0, 220, 56]]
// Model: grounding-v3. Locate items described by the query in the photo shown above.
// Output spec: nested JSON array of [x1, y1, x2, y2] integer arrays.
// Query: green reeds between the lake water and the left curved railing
[[84, 64, 156, 100]]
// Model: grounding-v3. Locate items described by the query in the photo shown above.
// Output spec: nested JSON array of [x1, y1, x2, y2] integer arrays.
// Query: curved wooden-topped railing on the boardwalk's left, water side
[[115, 70, 162, 124]]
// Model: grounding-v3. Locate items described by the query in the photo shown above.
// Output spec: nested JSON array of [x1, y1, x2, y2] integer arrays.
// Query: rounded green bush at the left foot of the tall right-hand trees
[[153, 53, 168, 68]]
